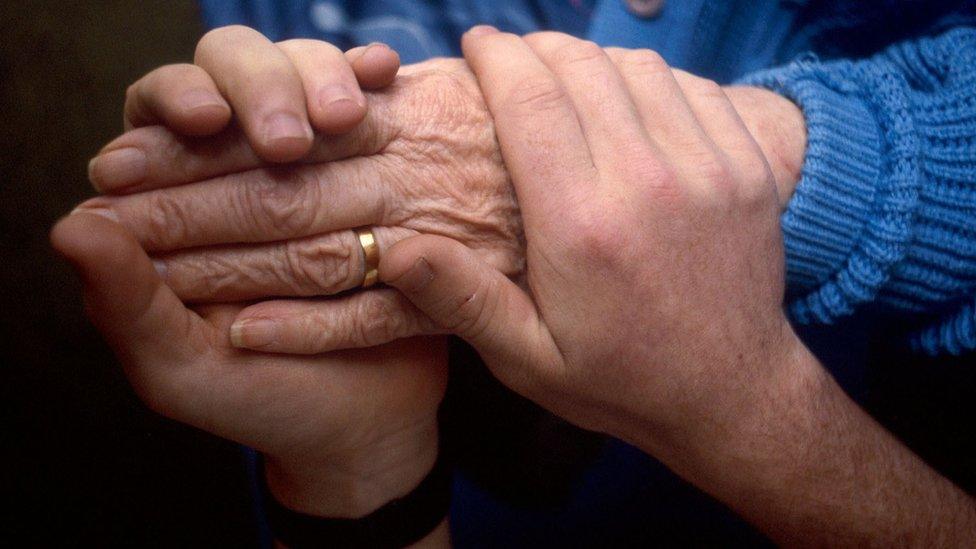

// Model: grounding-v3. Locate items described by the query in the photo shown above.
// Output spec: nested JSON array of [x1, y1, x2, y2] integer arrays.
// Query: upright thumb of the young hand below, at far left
[[51, 213, 208, 372]]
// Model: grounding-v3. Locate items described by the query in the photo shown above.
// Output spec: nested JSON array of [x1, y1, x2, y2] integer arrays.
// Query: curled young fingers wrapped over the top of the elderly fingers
[[104, 26, 400, 166]]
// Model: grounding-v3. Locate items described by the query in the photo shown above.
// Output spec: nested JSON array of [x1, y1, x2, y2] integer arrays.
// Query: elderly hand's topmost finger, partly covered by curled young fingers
[[89, 99, 396, 194]]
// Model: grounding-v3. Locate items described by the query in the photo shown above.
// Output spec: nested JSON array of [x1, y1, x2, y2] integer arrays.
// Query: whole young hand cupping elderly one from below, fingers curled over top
[[51, 29, 447, 524]]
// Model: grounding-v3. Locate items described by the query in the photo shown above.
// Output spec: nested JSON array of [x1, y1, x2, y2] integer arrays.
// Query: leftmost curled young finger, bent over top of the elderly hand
[[124, 64, 231, 136]]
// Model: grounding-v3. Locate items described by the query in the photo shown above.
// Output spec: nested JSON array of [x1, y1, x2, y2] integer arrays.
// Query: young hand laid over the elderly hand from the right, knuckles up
[[380, 28, 802, 456]]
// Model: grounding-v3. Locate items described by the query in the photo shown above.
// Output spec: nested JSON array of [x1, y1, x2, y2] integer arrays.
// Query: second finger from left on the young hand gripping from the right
[[525, 32, 653, 173]]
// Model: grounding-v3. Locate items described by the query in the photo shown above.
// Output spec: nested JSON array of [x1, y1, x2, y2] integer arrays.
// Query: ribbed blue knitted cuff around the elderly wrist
[[744, 60, 917, 323]]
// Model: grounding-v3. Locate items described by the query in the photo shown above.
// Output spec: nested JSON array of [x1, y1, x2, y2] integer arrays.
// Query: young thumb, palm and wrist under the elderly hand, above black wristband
[[51, 209, 447, 517]]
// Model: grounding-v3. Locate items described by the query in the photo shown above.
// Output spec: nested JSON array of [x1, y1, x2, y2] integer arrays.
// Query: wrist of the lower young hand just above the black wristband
[[264, 417, 438, 518]]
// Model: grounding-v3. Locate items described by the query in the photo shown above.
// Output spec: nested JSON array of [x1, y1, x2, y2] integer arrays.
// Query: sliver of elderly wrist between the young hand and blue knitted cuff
[[724, 86, 807, 208]]
